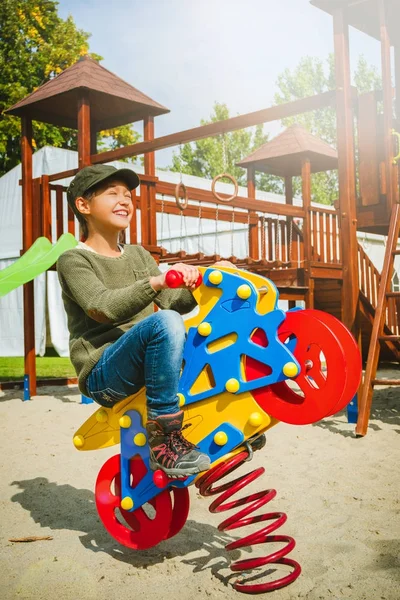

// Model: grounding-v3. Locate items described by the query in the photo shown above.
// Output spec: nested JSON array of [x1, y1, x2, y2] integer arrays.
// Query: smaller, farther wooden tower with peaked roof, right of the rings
[[238, 125, 341, 318]]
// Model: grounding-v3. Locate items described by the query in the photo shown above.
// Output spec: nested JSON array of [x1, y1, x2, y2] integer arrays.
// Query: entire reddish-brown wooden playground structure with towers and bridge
[[3, 0, 400, 435]]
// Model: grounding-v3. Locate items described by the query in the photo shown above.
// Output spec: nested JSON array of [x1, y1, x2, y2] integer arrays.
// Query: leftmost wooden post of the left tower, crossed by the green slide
[[21, 116, 36, 400]]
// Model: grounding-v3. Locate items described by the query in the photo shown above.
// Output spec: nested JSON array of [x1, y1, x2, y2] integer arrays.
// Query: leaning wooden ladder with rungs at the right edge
[[356, 204, 400, 436]]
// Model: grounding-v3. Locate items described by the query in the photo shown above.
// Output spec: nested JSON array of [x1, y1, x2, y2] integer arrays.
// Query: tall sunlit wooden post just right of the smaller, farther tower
[[333, 8, 359, 335]]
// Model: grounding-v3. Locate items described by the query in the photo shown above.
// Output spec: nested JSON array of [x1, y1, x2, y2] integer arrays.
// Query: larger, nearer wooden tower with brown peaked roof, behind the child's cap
[[5, 56, 169, 395]]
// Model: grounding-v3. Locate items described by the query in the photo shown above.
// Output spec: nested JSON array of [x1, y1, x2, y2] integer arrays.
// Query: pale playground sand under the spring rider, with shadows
[[0, 371, 400, 600]]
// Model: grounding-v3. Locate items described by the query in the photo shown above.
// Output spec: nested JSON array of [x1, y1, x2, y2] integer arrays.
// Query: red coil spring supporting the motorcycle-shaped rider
[[196, 450, 301, 594]]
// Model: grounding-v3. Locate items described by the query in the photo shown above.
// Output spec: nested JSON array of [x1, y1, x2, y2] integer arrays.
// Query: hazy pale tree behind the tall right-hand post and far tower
[[275, 54, 382, 204]]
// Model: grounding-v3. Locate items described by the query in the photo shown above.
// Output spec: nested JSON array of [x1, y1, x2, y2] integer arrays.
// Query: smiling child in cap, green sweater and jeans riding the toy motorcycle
[[57, 165, 210, 477]]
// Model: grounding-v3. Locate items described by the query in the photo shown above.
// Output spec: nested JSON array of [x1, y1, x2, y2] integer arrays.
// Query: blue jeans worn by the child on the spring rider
[[86, 310, 186, 419]]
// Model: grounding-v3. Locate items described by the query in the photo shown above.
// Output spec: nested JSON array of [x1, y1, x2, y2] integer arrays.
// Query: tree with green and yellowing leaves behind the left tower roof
[[0, 0, 138, 176]]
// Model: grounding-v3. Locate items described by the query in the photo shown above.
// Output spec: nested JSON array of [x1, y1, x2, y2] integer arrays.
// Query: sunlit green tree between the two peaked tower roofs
[[169, 102, 281, 192]]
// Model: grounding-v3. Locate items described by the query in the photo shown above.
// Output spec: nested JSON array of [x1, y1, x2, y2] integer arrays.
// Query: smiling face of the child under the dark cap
[[77, 179, 133, 232]]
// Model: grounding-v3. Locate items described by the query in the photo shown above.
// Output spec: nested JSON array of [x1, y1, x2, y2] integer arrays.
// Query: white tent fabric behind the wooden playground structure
[[0, 146, 400, 356]]
